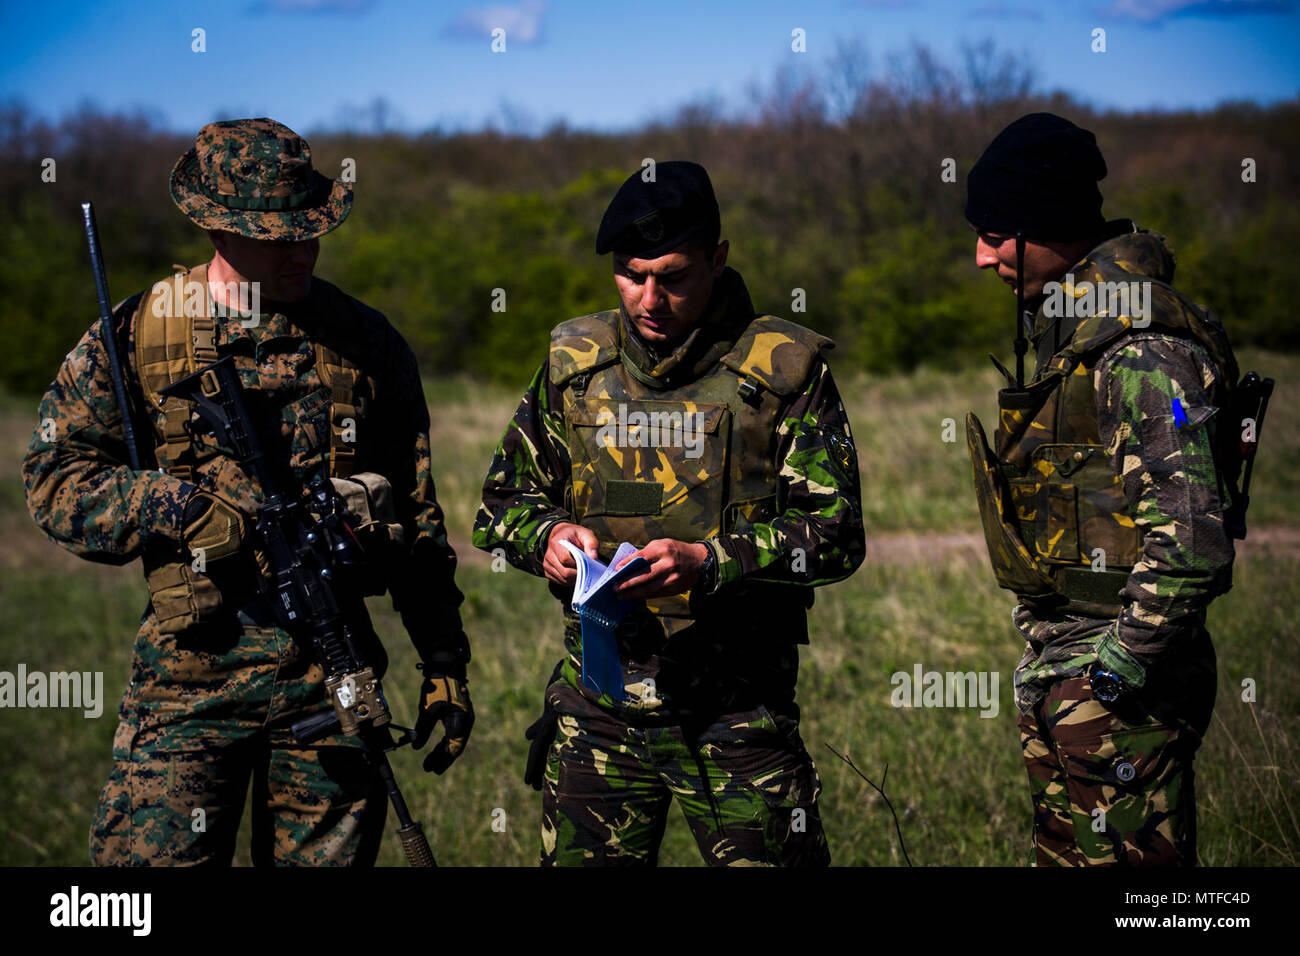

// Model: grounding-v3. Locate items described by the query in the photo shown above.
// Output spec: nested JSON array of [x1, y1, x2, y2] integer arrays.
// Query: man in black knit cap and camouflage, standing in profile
[[966, 113, 1240, 866]]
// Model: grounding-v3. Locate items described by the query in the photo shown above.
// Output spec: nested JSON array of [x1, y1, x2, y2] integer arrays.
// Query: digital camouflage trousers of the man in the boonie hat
[[90, 615, 387, 866]]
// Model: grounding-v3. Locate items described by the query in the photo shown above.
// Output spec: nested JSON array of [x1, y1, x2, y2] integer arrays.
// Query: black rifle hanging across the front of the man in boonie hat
[[161, 355, 437, 866]]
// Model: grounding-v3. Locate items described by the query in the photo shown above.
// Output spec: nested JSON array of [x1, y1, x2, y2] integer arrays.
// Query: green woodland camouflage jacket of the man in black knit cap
[[993, 230, 1238, 706]]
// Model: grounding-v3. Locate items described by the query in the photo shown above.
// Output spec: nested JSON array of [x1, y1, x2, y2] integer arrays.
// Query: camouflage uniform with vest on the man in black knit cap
[[969, 230, 1236, 865]]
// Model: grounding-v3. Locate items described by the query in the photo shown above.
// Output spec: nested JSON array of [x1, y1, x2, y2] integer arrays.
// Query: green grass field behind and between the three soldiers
[[0, 352, 1300, 865]]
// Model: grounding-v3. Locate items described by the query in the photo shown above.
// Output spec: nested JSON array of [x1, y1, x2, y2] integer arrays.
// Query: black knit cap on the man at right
[[966, 113, 1106, 242]]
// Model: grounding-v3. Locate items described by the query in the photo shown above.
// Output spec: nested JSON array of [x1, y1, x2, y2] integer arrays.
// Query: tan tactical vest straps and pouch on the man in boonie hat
[[131, 265, 364, 633]]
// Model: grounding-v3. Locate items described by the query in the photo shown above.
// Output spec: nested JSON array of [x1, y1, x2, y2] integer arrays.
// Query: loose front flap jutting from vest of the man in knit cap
[[966, 412, 1056, 601]]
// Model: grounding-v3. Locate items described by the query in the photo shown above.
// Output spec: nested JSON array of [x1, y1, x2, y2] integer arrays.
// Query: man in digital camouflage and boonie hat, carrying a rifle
[[22, 118, 473, 865]]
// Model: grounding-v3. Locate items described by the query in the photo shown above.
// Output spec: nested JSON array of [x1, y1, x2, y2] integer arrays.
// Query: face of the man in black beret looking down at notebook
[[614, 242, 727, 346]]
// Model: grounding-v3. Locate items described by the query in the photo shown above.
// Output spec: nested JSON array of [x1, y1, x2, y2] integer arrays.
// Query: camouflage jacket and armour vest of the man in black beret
[[473, 269, 865, 705]]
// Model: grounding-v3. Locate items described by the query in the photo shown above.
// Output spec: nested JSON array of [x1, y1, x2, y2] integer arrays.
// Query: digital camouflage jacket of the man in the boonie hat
[[22, 271, 468, 681]]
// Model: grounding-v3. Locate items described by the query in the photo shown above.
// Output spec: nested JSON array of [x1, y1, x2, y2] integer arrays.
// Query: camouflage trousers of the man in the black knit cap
[[1019, 674, 1214, 866]]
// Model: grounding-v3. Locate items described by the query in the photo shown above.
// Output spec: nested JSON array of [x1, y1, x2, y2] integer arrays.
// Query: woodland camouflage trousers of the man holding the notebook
[[542, 679, 831, 866]]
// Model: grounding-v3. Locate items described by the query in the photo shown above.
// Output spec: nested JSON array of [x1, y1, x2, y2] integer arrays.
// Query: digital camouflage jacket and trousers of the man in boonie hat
[[22, 121, 464, 865]]
